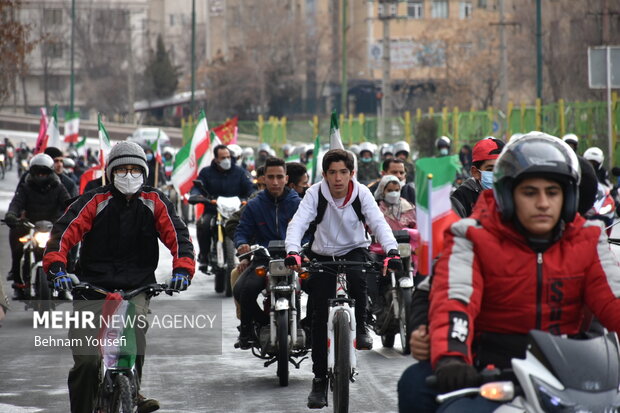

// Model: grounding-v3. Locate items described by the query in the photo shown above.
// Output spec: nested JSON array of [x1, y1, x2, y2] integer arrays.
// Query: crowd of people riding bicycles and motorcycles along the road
[[0, 132, 620, 413]]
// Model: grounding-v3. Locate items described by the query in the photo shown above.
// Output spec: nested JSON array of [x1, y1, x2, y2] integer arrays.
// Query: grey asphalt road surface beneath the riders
[[0, 165, 414, 413]]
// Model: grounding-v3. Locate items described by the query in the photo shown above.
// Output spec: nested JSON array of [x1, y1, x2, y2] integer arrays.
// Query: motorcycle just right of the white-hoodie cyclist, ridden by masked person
[[369, 230, 417, 354]]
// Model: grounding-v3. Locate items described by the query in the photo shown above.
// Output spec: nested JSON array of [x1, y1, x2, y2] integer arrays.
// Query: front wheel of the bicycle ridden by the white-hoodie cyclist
[[333, 311, 351, 413]]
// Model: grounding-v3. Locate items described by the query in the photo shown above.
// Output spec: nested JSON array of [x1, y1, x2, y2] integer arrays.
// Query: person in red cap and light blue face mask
[[450, 138, 504, 218]]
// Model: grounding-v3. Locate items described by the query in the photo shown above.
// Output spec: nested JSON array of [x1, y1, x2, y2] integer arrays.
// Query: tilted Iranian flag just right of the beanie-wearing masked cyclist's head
[[171, 110, 210, 195]]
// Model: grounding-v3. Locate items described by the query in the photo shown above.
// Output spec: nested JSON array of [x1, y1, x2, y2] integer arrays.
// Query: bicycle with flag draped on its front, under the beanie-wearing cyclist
[[72, 282, 178, 413]]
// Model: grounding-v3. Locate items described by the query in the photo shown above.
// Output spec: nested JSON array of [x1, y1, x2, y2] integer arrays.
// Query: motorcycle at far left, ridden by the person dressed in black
[[13, 220, 58, 311]]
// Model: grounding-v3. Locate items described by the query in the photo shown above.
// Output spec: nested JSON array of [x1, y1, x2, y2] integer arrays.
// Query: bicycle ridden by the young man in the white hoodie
[[302, 260, 381, 413]]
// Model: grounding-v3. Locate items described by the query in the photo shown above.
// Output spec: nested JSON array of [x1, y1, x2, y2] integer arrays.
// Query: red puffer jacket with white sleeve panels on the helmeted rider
[[429, 191, 620, 365]]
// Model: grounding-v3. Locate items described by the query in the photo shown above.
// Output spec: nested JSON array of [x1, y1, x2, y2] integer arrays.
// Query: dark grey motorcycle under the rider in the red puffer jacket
[[434, 330, 620, 413]]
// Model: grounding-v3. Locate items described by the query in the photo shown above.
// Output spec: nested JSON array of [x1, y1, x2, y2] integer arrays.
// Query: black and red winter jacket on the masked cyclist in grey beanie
[[43, 185, 195, 289]]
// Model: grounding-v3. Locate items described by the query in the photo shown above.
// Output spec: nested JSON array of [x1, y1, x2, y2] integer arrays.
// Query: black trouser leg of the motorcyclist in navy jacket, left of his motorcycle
[[233, 257, 269, 325]]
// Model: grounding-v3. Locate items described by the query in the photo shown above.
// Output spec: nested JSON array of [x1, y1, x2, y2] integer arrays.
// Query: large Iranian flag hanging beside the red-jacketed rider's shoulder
[[416, 155, 460, 275]]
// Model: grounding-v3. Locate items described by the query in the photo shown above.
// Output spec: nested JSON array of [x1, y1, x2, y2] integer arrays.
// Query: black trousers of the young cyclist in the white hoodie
[[308, 248, 369, 378]]
